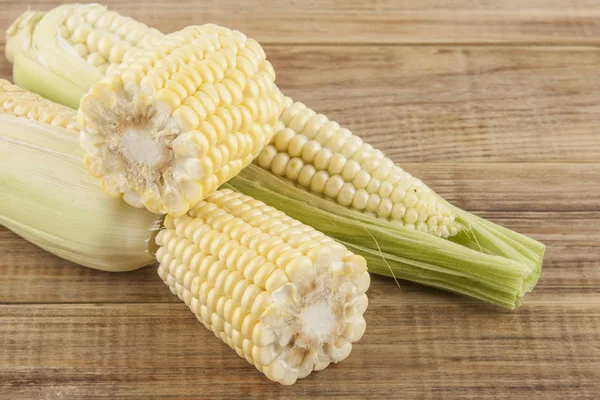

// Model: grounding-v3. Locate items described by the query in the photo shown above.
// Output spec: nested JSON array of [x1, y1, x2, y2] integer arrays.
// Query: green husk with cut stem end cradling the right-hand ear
[[226, 165, 545, 309]]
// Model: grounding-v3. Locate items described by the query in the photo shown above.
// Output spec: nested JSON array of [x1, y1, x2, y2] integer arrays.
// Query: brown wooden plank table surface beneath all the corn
[[0, 0, 600, 400]]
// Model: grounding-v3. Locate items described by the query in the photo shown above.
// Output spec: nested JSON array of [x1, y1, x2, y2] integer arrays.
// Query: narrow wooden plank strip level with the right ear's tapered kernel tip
[[402, 163, 600, 212]]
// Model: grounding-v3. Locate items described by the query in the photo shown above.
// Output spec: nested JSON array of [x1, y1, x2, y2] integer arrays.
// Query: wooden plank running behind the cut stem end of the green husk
[[0, 212, 600, 304]]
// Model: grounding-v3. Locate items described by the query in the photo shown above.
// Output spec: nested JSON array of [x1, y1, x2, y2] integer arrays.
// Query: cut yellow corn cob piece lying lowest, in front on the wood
[[156, 189, 369, 385]]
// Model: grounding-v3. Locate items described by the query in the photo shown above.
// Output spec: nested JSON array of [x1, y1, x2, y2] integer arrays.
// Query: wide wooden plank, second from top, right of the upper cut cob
[[0, 45, 600, 163]]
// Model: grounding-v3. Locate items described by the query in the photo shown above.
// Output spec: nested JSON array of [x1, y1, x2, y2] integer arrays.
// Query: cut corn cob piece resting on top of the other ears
[[78, 25, 282, 216]]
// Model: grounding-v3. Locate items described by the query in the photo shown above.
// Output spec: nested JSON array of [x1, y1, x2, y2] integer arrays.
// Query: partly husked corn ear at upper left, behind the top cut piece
[[5, 4, 164, 108]]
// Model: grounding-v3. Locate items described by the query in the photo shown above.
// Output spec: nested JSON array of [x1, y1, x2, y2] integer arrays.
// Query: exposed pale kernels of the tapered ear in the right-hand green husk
[[256, 97, 461, 238]]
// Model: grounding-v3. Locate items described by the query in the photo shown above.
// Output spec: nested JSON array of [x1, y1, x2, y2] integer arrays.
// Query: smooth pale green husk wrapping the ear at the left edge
[[0, 113, 162, 272]]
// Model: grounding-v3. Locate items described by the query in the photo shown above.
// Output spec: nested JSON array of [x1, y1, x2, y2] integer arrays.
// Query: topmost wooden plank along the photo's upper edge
[[0, 0, 600, 44]]
